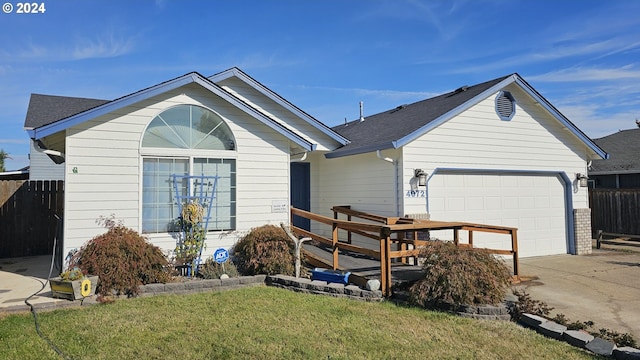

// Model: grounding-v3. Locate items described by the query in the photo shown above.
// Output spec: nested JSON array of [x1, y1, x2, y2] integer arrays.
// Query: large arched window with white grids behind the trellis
[[141, 105, 236, 233]]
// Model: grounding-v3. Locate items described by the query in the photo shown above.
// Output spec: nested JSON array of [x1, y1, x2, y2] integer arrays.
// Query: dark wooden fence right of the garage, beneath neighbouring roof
[[589, 189, 640, 238]]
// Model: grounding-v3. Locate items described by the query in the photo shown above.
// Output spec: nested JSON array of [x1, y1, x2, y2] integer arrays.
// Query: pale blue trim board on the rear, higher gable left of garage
[[209, 68, 349, 145]]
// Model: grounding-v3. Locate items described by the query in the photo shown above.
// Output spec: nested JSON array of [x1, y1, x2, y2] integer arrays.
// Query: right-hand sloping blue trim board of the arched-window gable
[[195, 77, 317, 151]]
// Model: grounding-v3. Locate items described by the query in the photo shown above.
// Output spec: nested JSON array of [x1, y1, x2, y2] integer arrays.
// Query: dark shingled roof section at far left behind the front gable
[[24, 94, 109, 129]]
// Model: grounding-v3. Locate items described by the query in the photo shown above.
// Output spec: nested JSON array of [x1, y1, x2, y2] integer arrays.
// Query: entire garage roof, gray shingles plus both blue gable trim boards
[[326, 73, 607, 158]]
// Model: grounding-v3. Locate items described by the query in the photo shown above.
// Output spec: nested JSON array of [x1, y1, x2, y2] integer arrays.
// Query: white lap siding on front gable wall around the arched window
[[64, 84, 290, 254]]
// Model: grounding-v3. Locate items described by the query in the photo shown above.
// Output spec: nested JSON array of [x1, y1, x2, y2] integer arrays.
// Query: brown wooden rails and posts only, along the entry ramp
[[291, 206, 519, 296]]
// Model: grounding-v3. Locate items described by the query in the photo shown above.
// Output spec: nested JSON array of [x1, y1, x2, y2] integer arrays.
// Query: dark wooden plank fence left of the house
[[0, 180, 64, 258]]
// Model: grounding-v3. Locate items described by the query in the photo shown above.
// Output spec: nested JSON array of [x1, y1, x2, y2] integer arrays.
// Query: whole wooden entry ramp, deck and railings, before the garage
[[291, 206, 519, 296]]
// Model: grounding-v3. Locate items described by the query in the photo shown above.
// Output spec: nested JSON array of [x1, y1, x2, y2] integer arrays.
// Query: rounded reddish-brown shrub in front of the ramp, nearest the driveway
[[409, 241, 511, 307]]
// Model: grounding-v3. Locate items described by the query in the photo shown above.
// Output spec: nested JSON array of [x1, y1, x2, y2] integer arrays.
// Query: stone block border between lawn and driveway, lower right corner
[[519, 313, 640, 360]]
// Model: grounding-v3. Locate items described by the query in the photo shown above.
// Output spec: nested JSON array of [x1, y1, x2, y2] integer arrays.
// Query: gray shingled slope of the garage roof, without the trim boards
[[330, 75, 511, 157]]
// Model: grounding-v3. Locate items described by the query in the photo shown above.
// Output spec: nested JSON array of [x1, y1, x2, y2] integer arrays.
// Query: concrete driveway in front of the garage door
[[517, 247, 640, 341]]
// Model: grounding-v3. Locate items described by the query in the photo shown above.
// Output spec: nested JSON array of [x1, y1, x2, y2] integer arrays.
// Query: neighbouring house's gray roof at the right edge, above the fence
[[589, 128, 640, 175]]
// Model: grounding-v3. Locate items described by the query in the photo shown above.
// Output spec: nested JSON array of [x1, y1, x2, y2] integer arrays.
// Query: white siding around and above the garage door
[[403, 87, 588, 213]]
